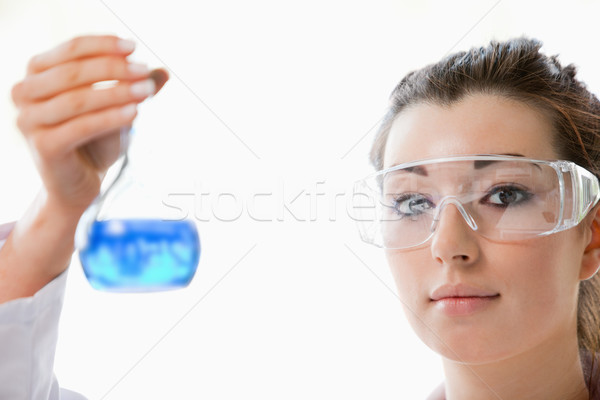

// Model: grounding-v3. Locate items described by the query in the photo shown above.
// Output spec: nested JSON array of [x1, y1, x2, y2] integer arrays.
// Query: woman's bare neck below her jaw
[[444, 336, 588, 400]]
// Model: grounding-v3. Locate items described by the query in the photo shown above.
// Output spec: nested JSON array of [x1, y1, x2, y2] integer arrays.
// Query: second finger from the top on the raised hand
[[13, 56, 150, 103]]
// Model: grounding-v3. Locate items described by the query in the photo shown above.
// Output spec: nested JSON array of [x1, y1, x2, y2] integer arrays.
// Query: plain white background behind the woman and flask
[[0, 0, 600, 400]]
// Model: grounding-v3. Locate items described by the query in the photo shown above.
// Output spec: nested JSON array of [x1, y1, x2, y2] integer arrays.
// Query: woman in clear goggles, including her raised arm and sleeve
[[0, 37, 600, 400]]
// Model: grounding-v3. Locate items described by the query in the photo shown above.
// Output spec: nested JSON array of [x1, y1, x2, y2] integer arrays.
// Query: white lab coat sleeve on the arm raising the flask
[[0, 224, 85, 400]]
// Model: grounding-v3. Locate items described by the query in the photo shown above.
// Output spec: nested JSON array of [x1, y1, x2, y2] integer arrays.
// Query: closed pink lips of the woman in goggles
[[430, 284, 500, 316]]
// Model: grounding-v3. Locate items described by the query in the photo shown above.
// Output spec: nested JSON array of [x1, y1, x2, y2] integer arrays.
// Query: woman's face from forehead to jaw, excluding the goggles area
[[384, 95, 591, 363]]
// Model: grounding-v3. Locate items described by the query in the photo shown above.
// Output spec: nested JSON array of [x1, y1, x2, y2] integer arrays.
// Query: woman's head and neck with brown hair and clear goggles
[[357, 39, 600, 400]]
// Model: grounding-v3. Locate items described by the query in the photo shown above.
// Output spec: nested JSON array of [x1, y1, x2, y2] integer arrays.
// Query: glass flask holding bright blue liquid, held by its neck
[[75, 100, 200, 292]]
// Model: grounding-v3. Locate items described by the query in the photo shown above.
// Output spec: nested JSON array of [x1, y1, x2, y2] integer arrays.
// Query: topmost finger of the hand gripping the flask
[[27, 35, 135, 75]]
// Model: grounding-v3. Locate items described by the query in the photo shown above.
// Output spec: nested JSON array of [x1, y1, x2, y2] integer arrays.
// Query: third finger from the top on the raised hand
[[17, 79, 156, 132]]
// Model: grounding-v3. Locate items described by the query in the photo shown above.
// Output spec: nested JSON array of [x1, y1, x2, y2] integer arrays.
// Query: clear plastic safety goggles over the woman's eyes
[[353, 155, 600, 249]]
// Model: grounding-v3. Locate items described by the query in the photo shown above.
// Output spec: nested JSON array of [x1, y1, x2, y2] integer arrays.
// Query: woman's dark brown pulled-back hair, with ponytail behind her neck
[[370, 38, 600, 395]]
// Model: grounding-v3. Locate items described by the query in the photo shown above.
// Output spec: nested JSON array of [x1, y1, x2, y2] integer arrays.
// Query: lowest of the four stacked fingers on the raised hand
[[27, 103, 137, 166]]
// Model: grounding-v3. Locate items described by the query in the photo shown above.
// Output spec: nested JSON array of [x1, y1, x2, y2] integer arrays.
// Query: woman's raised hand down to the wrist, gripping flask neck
[[12, 36, 167, 213]]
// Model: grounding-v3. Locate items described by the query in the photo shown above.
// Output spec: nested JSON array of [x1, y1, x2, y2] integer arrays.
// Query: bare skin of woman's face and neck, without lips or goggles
[[384, 94, 600, 400]]
